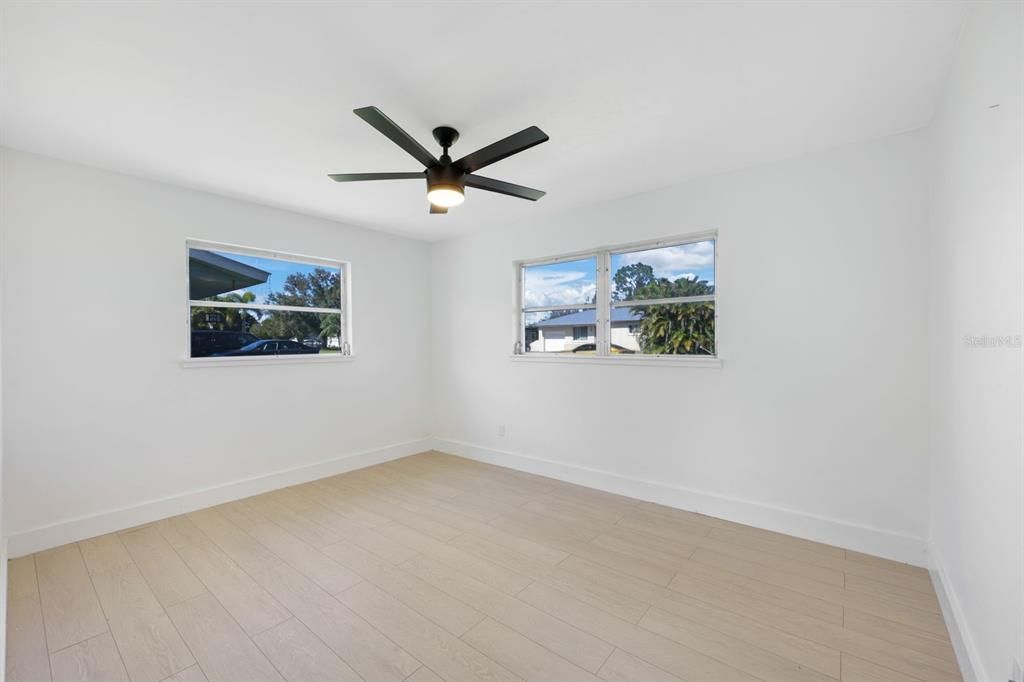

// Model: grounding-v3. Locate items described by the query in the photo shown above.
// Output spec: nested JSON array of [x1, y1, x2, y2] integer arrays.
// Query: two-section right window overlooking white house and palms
[[517, 233, 717, 357]]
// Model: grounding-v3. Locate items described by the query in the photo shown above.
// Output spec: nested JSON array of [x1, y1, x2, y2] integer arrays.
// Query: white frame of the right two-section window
[[512, 230, 722, 368]]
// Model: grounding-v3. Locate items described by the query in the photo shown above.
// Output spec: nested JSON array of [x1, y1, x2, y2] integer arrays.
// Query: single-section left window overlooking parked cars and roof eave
[[186, 241, 351, 358]]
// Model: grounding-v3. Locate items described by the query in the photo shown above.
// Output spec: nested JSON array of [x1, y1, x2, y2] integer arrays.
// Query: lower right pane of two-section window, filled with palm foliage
[[610, 301, 715, 355]]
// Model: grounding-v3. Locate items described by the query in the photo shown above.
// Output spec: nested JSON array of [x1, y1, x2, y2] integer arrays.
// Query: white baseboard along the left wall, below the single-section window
[[7, 438, 432, 558]]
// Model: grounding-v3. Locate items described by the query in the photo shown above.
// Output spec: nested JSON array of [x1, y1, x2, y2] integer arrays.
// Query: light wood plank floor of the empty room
[[7, 453, 961, 682]]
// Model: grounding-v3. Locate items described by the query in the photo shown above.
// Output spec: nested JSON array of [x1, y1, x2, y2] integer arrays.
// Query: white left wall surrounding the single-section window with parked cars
[[0, 151, 430, 555]]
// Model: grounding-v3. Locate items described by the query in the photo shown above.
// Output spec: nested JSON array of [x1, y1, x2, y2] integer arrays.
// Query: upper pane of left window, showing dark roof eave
[[188, 249, 341, 308]]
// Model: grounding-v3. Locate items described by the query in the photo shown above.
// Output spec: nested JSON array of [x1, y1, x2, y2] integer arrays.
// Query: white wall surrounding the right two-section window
[[433, 133, 927, 563]]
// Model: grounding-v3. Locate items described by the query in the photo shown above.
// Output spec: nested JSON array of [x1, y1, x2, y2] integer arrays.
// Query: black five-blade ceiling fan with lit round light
[[328, 106, 548, 213]]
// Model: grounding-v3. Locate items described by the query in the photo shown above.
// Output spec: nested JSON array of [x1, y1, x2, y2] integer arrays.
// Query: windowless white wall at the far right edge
[[929, 2, 1024, 680]]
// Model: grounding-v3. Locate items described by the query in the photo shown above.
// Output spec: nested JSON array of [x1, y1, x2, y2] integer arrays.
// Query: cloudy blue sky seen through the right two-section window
[[523, 240, 715, 307]]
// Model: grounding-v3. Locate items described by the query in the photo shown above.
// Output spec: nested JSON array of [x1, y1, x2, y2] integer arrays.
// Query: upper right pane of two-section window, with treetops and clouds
[[611, 240, 715, 301]]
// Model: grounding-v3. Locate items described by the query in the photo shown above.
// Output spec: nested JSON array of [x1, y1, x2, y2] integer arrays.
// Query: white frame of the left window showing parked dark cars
[[181, 239, 354, 368]]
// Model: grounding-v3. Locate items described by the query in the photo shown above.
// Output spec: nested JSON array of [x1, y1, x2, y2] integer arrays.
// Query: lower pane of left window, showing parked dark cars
[[190, 306, 342, 357]]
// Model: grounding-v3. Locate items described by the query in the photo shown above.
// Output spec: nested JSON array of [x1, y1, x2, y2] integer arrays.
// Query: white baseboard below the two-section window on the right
[[433, 438, 929, 566]]
